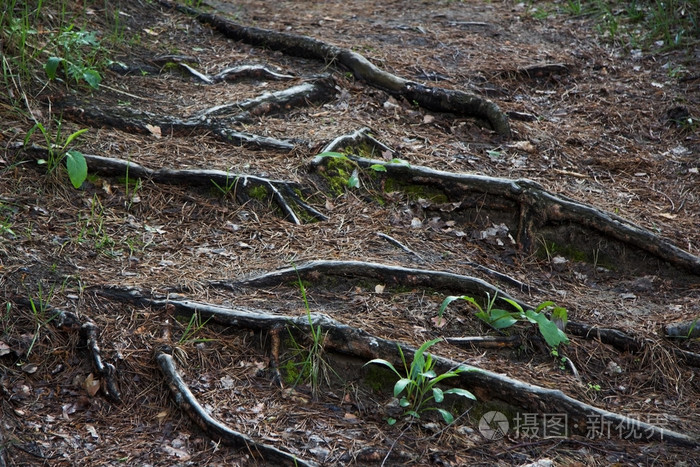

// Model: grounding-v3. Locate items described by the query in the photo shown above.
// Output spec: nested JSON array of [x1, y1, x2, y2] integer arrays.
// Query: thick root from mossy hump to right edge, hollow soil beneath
[[311, 129, 700, 280]]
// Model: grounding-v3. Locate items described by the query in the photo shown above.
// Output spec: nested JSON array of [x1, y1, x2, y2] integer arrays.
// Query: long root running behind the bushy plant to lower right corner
[[96, 287, 700, 446]]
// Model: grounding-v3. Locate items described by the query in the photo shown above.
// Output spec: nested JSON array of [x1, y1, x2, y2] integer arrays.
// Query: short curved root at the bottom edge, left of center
[[155, 346, 318, 467]]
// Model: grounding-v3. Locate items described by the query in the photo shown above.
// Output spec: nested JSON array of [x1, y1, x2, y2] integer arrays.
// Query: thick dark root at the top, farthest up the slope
[[159, 0, 511, 138]]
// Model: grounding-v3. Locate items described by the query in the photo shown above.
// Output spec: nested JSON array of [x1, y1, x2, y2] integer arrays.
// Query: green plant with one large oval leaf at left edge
[[24, 120, 87, 188]]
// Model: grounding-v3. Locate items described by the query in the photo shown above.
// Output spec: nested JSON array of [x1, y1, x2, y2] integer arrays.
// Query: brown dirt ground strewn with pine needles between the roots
[[0, 0, 700, 466]]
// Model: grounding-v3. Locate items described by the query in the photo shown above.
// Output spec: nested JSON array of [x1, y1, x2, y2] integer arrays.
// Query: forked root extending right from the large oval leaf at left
[[13, 144, 327, 224]]
